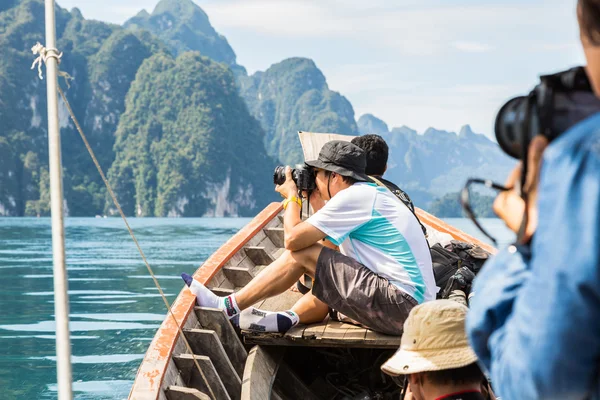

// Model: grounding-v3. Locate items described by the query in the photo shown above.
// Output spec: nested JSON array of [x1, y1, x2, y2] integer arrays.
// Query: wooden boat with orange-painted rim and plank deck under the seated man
[[129, 203, 493, 400]]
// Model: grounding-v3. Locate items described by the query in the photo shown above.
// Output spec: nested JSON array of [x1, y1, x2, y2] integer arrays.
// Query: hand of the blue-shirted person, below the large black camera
[[494, 135, 548, 242]]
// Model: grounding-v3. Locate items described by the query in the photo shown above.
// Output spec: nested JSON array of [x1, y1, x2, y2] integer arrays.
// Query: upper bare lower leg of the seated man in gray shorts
[[235, 244, 323, 310]]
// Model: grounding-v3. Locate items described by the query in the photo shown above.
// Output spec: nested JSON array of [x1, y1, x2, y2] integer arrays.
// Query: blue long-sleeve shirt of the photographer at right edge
[[467, 114, 600, 400]]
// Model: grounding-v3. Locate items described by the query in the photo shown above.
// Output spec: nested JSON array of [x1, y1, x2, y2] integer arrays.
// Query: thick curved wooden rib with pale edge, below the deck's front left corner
[[241, 346, 285, 400]]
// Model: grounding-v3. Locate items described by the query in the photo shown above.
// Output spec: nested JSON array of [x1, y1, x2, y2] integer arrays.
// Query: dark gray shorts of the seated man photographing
[[312, 247, 417, 335]]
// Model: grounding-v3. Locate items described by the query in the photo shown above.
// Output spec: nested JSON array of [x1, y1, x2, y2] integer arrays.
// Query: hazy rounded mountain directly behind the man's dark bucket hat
[[240, 58, 358, 165]]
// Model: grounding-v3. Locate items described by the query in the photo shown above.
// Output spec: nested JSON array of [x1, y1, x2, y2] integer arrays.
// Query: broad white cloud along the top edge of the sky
[[203, 0, 569, 56]]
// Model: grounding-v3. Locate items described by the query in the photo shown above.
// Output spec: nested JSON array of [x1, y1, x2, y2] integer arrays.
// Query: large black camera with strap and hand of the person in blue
[[461, 67, 600, 244]]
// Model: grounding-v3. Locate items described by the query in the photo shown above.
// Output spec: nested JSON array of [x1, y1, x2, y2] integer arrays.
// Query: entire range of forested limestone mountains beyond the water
[[0, 0, 513, 217]]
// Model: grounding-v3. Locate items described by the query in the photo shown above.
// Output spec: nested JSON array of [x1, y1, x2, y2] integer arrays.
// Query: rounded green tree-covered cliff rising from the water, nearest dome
[[109, 52, 274, 217]]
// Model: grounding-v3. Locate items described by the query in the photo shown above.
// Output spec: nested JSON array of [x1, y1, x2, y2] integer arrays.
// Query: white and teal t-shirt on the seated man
[[306, 182, 437, 303]]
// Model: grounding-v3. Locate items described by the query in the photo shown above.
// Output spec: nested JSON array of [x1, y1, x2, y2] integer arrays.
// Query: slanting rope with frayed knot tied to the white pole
[[31, 43, 217, 400]]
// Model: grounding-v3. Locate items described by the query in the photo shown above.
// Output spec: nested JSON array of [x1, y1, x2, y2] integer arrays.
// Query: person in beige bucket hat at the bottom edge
[[381, 300, 486, 400]]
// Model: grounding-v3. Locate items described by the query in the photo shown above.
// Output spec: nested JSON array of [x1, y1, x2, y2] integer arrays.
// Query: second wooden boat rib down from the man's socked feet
[[183, 329, 242, 400]]
